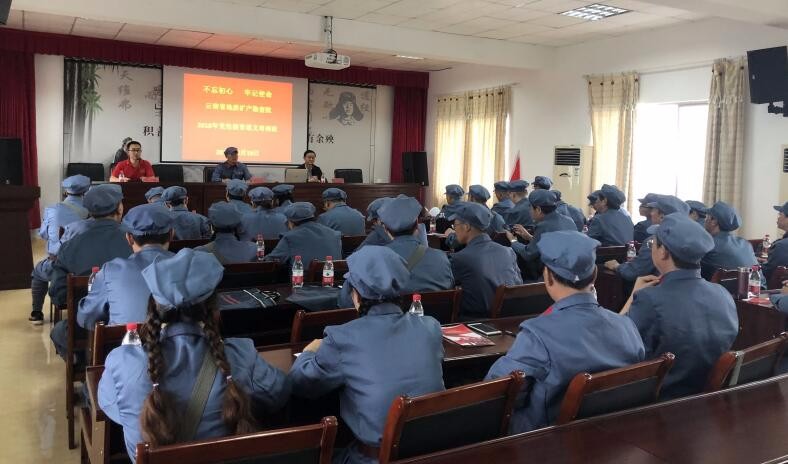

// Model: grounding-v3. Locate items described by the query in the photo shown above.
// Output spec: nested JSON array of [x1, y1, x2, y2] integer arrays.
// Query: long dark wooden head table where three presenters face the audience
[[113, 182, 424, 218]]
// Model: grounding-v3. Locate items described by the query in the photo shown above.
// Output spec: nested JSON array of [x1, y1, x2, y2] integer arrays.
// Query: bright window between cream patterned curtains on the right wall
[[632, 102, 709, 209]]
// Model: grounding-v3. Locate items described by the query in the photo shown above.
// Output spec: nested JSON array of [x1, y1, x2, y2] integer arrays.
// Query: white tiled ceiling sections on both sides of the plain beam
[[0, 0, 707, 71]]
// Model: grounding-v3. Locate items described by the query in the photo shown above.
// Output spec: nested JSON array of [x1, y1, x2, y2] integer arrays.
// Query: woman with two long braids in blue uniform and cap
[[98, 249, 290, 462]]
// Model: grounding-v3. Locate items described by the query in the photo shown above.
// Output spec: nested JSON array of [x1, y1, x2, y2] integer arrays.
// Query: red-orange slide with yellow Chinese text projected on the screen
[[182, 74, 293, 163]]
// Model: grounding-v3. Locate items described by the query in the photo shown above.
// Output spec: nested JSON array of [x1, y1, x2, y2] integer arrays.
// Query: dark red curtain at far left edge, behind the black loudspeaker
[[0, 50, 41, 229]]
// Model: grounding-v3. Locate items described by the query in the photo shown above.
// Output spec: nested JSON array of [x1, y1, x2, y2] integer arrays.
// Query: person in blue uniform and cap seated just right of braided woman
[[290, 245, 444, 464]]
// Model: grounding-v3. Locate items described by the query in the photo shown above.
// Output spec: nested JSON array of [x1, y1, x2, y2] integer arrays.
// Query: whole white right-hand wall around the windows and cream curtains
[[426, 19, 788, 238]]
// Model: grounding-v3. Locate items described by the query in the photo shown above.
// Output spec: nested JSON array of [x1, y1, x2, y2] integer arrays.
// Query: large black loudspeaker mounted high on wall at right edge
[[747, 47, 788, 103]]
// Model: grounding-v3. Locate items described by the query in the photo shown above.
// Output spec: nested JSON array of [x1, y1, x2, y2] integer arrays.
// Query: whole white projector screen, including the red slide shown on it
[[161, 66, 308, 165]]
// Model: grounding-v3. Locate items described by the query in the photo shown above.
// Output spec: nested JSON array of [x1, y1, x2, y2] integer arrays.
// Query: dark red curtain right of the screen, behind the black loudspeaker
[[391, 87, 427, 182]]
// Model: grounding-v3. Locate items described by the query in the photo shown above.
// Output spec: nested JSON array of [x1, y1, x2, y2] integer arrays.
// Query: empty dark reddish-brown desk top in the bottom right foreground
[[397, 375, 788, 464]]
